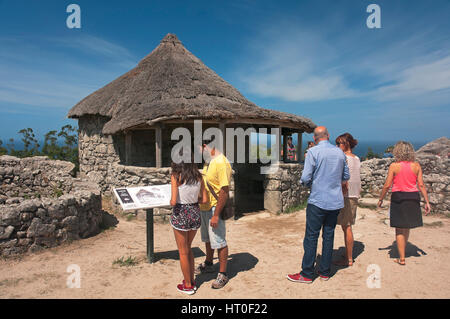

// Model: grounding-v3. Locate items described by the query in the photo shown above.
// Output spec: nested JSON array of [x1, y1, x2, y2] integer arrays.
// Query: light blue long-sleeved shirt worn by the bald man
[[300, 141, 350, 210]]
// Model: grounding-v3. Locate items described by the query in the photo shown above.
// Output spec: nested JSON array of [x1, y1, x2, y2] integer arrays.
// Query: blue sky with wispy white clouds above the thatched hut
[[0, 0, 450, 144]]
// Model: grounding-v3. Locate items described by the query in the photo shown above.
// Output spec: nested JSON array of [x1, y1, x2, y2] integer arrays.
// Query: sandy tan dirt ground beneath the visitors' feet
[[0, 200, 450, 299]]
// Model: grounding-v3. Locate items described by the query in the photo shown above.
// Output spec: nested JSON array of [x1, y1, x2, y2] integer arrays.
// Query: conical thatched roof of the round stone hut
[[68, 34, 315, 134]]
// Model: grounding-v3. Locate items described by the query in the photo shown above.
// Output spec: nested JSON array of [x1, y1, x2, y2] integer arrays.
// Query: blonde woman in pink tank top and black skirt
[[378, 141, 431, 265]]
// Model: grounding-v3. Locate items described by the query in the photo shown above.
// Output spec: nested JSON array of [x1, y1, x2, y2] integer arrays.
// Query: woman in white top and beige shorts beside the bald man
[[335, 133, 361, 266]]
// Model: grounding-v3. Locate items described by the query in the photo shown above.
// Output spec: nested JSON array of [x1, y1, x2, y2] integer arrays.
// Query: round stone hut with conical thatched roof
[[68, 34, 316, 212]]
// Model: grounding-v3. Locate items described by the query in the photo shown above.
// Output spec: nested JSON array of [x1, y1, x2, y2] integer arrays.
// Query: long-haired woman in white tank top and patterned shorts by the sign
[[170, 161, 208, 295]]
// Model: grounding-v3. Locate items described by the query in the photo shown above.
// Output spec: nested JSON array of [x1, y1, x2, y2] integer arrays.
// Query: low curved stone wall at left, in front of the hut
[[0, 155, 102, 256]]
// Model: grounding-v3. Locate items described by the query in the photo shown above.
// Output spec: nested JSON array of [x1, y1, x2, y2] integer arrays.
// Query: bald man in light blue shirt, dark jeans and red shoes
[[287, 126, 350, 283]]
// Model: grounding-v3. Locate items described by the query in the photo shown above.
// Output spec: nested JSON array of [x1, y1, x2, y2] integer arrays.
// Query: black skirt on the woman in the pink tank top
[[390, 192, 423, 228]]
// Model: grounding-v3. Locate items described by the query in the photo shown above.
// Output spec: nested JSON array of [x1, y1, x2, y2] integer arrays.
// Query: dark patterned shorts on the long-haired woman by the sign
[[170, 203, 201, 231]]
